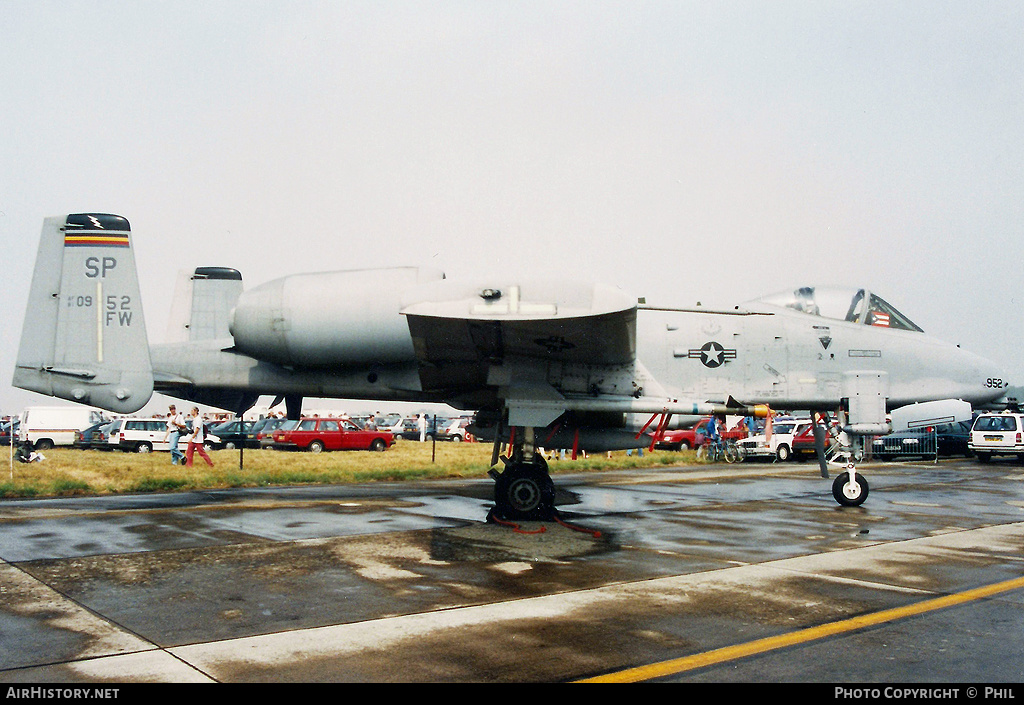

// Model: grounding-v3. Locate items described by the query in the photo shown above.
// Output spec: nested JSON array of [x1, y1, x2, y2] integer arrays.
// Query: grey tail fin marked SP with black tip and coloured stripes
[[12, 213, 153, 414]]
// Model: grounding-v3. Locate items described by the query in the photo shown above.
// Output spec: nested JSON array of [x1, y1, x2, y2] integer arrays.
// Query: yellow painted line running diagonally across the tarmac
[[577, 578, 1024, 682]]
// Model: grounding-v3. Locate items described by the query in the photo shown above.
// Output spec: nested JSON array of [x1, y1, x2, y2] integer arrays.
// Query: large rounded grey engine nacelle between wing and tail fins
[[230, 267, 444, 367]]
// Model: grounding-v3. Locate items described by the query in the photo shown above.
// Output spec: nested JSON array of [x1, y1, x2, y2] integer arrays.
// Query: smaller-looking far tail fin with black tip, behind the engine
[[168, 266, 242, 342]]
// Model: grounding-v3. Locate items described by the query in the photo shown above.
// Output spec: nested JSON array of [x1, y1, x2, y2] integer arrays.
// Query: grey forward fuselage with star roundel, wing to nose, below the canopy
[[637, 306, 1008, 409]]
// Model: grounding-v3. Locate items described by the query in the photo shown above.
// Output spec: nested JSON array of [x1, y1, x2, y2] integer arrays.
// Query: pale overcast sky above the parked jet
[[0, 0, 1024, 413]]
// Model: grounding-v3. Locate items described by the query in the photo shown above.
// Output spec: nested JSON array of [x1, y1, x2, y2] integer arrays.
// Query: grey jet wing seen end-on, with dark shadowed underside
[[401, 281, 765, 427]]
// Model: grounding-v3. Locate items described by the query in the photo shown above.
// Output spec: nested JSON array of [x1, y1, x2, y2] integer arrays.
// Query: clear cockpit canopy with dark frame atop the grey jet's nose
[[758, 287, 924, 333]]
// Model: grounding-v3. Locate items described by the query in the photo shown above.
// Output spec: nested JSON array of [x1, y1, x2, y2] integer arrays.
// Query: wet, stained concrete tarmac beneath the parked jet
[[0, 460, 1024, 683]]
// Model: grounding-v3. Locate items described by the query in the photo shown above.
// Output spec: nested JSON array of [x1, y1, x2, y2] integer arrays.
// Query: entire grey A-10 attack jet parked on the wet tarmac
[[13, 214, 1009, 519]]
